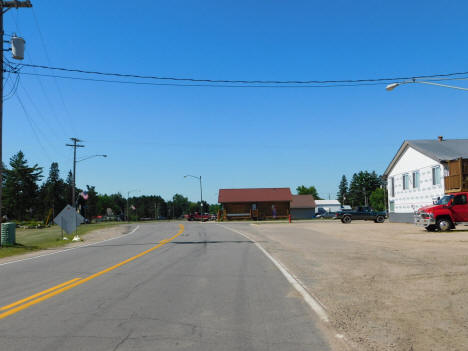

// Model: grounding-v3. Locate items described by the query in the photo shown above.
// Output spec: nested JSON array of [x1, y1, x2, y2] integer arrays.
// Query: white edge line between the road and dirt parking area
[[219, 224, 330, 323]]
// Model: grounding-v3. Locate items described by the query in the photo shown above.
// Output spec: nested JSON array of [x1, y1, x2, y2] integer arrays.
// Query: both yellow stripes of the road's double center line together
[[0, 224, 184, 319]]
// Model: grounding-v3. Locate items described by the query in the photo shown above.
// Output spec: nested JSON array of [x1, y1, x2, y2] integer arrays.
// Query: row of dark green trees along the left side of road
[[2, 151, 218, 221]]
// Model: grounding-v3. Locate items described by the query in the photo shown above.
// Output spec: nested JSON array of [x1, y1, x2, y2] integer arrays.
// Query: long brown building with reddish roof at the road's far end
[[218, 188, 292, 220]]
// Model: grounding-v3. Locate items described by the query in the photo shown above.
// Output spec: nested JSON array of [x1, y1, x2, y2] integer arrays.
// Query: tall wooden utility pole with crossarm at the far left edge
[[0, 0, 32, 223]]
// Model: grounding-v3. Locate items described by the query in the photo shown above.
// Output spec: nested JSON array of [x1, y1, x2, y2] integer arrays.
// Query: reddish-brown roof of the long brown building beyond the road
[[218, 188, 292, 204]]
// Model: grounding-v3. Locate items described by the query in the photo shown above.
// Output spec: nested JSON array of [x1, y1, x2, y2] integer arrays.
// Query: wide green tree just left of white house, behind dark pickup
[[348, 171, 382, 206]]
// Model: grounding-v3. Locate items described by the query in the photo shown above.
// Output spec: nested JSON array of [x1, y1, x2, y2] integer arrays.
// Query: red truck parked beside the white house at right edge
[[414, 192, 468, 232]]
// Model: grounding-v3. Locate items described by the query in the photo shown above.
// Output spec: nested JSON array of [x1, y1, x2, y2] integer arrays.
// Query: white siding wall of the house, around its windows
[[387, 147, 446, 213]]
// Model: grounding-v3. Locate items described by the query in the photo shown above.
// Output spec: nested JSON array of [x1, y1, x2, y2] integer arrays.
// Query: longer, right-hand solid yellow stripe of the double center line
[[0, 224, 184, 319]]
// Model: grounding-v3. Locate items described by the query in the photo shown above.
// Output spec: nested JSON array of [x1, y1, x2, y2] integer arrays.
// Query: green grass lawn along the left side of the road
[[0, 222, 126, 258]]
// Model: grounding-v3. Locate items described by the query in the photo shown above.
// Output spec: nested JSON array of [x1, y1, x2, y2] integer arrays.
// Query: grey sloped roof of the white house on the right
[[384, 139, 468, 176]]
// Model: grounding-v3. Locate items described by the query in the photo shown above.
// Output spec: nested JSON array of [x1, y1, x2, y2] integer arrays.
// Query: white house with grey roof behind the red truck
[[384, 137, 468, 223]]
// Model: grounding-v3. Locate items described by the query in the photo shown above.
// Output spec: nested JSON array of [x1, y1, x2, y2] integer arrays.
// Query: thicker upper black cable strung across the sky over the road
[[21, 63, 468, 84]]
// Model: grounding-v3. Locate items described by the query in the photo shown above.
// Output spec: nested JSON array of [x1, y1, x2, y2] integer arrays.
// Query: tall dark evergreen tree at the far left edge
[[3, 151, 42, 220]]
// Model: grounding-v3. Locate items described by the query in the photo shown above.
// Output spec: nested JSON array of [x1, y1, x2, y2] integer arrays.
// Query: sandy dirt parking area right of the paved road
[[231, 221, 468, 351]]
